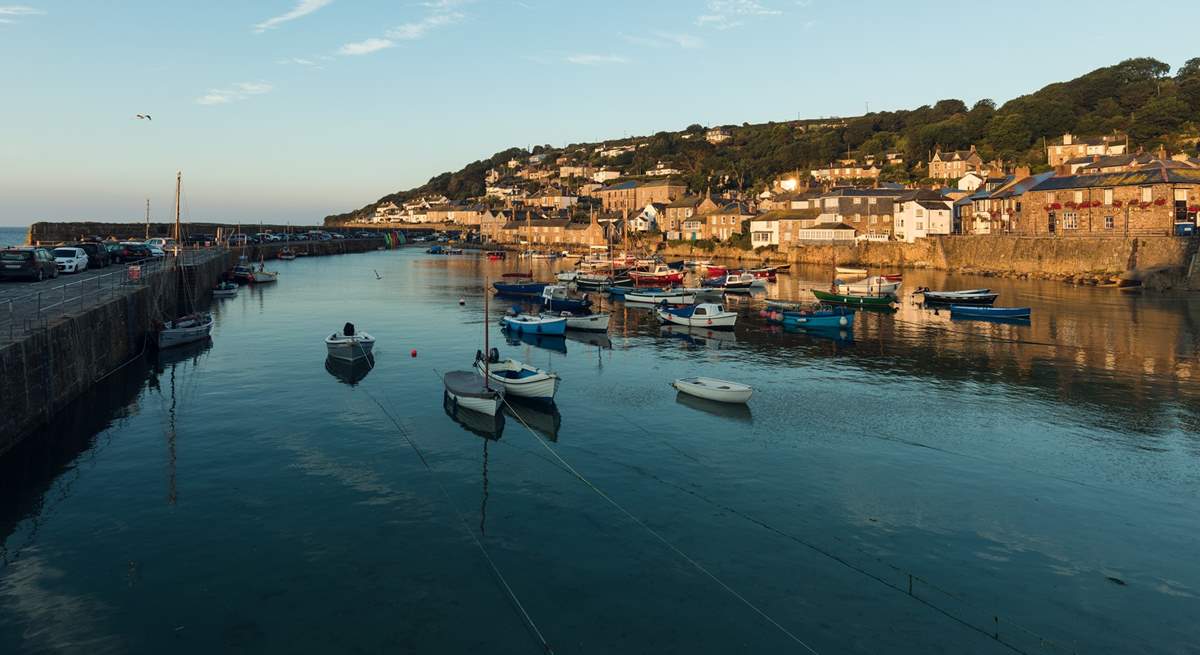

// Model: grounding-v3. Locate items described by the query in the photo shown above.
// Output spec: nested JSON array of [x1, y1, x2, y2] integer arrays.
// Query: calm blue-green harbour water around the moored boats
[[0, 250, 1200, 654]]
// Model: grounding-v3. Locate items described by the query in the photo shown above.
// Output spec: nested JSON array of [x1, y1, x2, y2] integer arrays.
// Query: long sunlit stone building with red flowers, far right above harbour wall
[[1012, 162, 1200, 236]]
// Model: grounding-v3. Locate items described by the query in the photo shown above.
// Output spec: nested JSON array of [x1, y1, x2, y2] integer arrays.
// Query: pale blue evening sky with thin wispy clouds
[[0, 0, 1200, 226]]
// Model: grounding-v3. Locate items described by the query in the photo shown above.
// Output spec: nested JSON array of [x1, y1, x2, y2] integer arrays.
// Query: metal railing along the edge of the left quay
[[0, 257, 178, 341]]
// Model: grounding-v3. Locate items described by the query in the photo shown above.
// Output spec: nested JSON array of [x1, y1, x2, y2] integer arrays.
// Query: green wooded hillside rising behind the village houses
[[326, 58, 1200, 222]]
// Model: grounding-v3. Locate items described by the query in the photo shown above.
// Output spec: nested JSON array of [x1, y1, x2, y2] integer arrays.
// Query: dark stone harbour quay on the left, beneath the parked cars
[[0, 230, 385, 455]]
